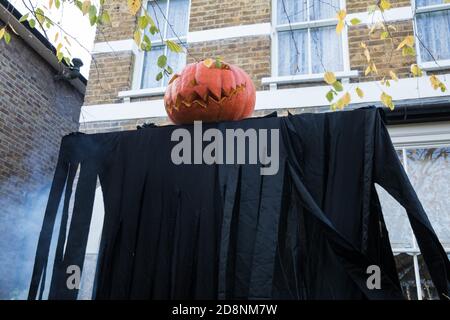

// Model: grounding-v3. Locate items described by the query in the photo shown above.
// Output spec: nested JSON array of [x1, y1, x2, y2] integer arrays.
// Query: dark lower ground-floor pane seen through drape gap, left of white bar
[[395, 253, 417, 300]]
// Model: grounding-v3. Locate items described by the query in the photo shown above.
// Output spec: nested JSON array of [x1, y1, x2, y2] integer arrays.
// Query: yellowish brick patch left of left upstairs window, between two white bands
[[84, 51, 134, 105]]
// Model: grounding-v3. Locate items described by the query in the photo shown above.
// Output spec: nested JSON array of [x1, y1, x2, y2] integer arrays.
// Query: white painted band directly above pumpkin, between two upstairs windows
[[187, 23, 271, 43]]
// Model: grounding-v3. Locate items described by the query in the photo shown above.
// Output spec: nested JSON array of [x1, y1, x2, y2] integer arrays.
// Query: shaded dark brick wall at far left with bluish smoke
[[0, 23, 83, 299]]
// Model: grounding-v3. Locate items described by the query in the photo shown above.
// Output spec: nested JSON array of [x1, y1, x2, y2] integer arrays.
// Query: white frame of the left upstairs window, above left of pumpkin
[[132, 0, 192, 92]]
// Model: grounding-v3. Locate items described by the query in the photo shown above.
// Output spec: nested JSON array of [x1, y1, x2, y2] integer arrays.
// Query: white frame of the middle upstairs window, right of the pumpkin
[[261, 0, 358, 89]]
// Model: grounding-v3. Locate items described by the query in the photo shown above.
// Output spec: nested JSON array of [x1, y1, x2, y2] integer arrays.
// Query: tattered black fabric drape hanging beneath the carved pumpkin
[[29, 108, 450, 299]]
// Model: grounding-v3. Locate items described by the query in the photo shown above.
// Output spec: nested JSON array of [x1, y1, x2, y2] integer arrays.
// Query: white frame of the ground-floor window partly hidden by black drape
[[388, 123, 450, 300]]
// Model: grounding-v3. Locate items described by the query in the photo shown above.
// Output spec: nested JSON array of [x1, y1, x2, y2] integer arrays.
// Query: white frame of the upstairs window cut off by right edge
[[411, 0, 450, 71]]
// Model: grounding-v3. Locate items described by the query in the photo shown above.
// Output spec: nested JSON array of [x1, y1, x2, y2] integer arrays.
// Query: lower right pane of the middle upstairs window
[[311, 26, 344, 73]]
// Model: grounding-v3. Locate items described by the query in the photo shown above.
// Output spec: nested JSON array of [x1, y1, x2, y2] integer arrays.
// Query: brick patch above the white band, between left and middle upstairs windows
[[189, 0, 271, 31]]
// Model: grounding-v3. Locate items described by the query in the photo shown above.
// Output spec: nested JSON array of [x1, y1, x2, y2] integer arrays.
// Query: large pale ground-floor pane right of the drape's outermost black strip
[[406, 146, 450, 247]]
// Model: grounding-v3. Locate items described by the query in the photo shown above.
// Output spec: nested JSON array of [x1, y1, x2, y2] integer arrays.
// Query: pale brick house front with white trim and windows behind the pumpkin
[[80, 0, 450, 299]]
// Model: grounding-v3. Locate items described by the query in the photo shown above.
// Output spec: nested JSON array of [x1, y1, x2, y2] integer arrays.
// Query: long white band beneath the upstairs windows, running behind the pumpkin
[[80, 74, 450, 123]]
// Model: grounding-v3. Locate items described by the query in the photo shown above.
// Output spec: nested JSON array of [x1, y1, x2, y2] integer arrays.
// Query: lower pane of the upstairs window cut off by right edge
[[417, 10, 450, 61]]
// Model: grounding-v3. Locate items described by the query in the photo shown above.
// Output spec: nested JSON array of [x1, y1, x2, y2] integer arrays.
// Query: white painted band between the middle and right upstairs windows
[[345, 6, 413, 25]]
